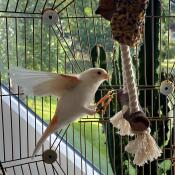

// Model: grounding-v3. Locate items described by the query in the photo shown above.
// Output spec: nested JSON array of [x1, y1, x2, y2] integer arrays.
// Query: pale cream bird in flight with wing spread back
[[9, 67, 109, 159]]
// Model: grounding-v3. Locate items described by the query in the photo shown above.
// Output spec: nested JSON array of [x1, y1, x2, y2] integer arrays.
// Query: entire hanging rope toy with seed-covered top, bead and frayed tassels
[[98, 0, 162, 166]]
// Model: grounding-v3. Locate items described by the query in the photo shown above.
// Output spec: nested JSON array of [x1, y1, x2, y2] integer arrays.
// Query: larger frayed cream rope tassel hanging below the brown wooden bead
[[125, 128, 162, 166]]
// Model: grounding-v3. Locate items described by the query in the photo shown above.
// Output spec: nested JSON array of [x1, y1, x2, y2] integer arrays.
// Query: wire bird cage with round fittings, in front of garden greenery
[[0, 0, 175, 175]]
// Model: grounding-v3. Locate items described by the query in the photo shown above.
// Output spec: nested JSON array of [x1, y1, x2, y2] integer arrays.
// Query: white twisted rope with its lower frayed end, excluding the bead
[[120, 45, 162, 166]]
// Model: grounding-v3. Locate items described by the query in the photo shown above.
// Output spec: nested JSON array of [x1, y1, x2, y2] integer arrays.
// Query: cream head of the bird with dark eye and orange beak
[[80, 68, 109, 83]]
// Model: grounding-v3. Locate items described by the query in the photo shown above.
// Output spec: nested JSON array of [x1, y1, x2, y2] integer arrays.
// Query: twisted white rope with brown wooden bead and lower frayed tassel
[[121, 45, 162, 166]]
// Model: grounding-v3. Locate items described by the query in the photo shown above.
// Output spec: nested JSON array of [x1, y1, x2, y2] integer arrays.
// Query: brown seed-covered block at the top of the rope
[[111, 0, 148, 46]]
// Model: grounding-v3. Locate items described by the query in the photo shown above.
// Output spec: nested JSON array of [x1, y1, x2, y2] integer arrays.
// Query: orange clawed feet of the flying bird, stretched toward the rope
[[96, 90, 115, 113]]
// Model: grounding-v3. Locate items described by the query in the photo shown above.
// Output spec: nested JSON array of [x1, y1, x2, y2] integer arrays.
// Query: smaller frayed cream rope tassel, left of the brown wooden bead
[[110, 105, 133, 136]]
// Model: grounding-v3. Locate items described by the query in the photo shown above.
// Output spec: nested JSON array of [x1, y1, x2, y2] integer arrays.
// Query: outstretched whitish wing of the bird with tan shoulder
[[9, 67, 80, 96]]
